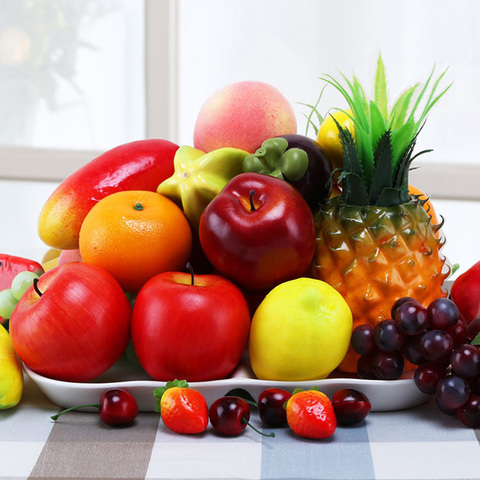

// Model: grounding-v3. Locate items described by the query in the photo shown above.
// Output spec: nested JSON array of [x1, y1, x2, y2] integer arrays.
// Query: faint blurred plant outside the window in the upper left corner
[[0, 0, 116, 110]]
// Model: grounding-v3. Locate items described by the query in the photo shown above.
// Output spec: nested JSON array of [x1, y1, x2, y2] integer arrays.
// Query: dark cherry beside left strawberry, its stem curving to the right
[[209, 396, 275, 437]]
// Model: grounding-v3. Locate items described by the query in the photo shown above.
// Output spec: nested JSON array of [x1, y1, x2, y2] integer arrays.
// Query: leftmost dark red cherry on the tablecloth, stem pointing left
[[50, 388, 138, 425]]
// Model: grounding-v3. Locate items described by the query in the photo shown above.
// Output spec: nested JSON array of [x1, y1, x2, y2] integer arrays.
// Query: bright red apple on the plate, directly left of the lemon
[[132, 272, 250, 382]]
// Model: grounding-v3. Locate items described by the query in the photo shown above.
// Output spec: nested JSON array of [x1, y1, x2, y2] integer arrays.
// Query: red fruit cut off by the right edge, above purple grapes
[[450, 262, 480, 325]]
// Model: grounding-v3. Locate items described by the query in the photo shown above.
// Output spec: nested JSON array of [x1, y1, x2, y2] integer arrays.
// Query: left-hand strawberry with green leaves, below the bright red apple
[[153, 380, 208, 433]]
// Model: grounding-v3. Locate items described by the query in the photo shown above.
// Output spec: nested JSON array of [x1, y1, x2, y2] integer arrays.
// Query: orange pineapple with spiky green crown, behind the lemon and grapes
[[311, 57, 449, 372]]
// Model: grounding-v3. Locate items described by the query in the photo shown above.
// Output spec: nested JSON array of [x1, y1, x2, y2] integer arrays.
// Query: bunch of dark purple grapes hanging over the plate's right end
[[352, 297, 480, 428]]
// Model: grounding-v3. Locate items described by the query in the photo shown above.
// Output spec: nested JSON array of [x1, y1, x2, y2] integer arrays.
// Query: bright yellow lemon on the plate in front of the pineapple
[[249, 277, 352, 381]]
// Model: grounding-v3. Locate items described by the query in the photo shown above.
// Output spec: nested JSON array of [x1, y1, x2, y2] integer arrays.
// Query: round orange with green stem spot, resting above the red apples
[[79, 190, 192, 293]]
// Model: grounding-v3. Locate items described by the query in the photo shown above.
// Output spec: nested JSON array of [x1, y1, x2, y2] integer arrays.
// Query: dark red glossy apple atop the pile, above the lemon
[[199, 173, 316, 290]]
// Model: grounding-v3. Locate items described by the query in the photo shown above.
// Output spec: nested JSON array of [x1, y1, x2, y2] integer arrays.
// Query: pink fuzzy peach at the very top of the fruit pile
[[193, 81, 297, 153]]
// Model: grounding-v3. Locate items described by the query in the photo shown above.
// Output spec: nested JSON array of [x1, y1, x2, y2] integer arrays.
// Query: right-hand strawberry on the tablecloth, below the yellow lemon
[[286, 389, 337, 438]]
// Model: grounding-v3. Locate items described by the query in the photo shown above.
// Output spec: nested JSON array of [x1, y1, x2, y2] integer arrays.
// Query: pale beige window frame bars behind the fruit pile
[[0, 0, 480, 201]]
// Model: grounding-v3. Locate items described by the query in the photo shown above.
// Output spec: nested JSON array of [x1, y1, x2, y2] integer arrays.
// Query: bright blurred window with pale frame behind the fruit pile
[[0, 0, 480, 274]]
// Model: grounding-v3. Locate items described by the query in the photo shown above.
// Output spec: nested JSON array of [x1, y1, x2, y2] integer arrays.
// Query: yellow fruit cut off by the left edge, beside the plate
[[0, 325, 23, 410]]
